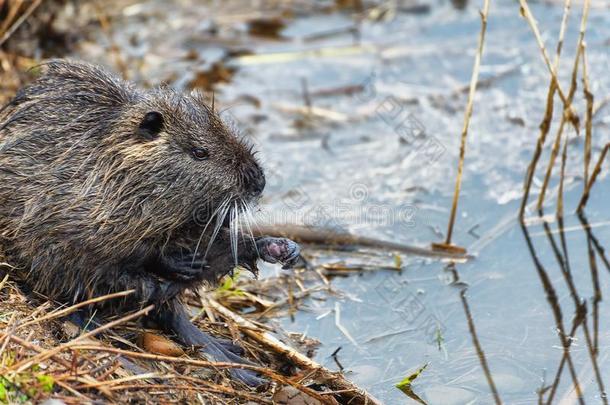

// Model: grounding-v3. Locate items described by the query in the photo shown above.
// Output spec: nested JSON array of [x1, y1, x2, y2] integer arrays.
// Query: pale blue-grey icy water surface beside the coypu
[[79, 0, 610, 405]]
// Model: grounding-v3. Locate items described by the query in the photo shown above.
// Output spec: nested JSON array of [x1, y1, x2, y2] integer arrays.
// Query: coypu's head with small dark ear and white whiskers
[[110, 89, 265, 229]]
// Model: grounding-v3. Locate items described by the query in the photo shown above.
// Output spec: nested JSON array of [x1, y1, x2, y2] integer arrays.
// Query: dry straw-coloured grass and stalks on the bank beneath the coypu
[[0, 264, 378, 404]]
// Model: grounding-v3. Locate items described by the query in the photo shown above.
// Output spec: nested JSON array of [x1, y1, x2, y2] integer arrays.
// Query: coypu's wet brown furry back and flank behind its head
[[0, 62, 144, 296]]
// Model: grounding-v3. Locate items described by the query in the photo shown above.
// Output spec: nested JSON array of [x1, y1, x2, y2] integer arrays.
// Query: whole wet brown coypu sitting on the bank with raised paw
[[0, 60, 299, 385]]
